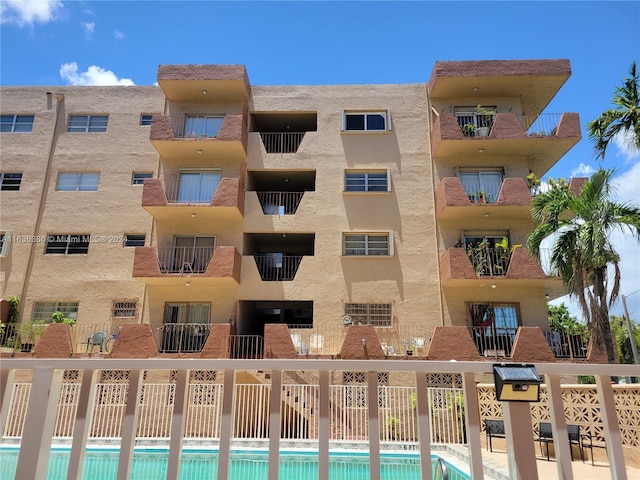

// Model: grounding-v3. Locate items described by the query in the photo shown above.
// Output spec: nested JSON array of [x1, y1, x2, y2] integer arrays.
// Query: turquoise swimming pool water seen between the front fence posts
[[0, 448, 470, 480]]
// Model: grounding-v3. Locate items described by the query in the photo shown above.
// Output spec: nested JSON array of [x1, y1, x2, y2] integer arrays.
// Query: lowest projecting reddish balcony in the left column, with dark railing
[[132, 246, 241, 286]]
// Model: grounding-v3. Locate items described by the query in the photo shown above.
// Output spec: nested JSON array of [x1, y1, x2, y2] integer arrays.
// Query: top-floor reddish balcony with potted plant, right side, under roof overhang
[[431, 112, 582, 172]]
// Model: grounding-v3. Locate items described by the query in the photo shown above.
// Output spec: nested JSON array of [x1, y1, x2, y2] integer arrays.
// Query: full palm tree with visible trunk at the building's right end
[[527, 168, 640, 363]]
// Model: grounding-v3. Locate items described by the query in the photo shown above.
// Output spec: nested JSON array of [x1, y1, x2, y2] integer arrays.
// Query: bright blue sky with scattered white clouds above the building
[[0, 0, 640, 321]]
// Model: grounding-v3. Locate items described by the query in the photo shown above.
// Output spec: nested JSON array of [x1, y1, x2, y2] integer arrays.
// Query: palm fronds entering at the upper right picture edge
[[587, 62, 640, 160]]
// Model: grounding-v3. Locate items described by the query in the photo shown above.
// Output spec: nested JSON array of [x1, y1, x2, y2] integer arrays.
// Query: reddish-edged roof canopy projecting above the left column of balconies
[[158, 65, 251, 103]]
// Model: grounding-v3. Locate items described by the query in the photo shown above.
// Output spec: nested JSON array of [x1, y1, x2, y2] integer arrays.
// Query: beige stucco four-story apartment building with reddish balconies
[[0, 60, 580, 356]]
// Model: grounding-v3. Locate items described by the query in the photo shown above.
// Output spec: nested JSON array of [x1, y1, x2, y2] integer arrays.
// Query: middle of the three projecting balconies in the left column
[[142, 178, 244, 221]]
